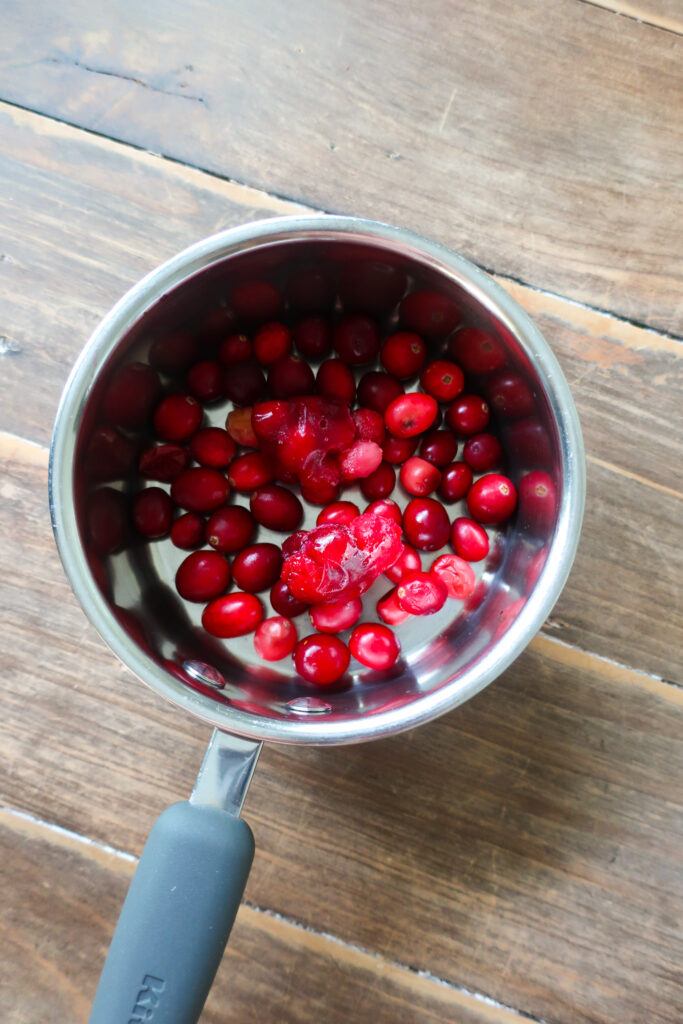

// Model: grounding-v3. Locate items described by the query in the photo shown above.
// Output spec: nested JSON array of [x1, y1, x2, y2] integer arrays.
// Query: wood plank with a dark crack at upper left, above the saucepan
[[0, 0, 683, 335]]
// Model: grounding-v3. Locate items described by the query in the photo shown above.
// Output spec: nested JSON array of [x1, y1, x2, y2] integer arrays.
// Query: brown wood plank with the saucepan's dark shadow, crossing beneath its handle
[[0, 436, 683, 1024]]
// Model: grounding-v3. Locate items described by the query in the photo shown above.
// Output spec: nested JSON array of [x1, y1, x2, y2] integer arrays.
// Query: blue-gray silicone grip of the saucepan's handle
[[90, 803, 254, 1024]]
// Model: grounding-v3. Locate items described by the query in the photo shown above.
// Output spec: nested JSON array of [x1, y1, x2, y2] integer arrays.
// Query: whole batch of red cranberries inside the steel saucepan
[[108, 282, 530, 686]]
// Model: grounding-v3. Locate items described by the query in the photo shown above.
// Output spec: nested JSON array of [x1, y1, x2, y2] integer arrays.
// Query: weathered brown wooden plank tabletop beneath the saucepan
[[0, 0, 683, 1024]]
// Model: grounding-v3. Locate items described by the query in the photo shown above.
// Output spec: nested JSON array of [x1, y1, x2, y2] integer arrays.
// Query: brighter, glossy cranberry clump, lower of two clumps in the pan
[[282, 514, 402, 604]]
